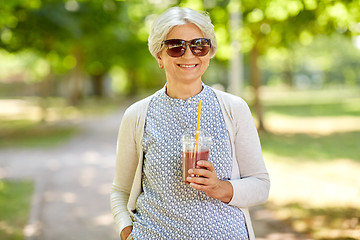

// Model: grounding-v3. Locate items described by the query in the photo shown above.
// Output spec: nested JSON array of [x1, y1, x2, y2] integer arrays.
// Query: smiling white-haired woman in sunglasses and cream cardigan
[[111, 7, 270, 240]]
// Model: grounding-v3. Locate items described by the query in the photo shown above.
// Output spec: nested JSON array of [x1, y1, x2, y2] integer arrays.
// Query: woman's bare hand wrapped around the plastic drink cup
[[187, 160, 233, 203]]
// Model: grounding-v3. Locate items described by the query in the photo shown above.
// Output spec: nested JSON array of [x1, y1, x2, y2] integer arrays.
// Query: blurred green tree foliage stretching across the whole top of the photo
[[0, 0, 360, 96]]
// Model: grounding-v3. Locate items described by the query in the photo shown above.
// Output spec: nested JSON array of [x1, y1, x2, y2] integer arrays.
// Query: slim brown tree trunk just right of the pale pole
[[250, 46, 266, 132]]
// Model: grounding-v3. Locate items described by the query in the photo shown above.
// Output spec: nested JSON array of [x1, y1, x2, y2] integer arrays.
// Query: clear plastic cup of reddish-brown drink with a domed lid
[[181, 130, 212, 184]]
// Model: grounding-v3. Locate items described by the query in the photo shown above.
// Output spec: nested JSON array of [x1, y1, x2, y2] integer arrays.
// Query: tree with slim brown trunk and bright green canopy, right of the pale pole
[[242, 0, 360, 131]]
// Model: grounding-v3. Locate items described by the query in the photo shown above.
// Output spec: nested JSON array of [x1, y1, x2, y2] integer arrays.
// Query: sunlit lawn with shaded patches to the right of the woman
[[261, 89, 360, 240]]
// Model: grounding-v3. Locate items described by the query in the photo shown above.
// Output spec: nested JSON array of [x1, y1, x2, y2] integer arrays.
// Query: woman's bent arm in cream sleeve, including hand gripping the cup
[[187, 97, 270, 207]]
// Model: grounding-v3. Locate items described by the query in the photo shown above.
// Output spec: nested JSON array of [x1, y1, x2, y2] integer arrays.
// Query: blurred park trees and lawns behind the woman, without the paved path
[[0, 0, 360, 240]]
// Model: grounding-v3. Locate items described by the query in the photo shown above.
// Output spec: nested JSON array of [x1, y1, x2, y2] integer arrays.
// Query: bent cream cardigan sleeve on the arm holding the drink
[[229, 98, 270, 208]]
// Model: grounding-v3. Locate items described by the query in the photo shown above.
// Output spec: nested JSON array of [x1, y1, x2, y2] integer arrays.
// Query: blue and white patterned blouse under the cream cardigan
[[132, 84, 248, 240]]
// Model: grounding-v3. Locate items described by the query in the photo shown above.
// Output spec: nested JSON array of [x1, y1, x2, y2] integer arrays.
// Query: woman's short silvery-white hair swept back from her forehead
[[148, 7, 217, 58]]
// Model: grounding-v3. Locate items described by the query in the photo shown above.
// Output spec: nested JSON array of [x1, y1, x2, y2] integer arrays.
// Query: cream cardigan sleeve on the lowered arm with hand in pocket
[[110, 107, 138, 236]]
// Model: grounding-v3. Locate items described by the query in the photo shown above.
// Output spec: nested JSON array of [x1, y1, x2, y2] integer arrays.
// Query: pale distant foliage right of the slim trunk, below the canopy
[[261, 34, 360, 88]]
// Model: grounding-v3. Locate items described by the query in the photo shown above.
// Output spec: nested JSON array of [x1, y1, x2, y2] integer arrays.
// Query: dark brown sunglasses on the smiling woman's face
[[163, 38, 211, 57]]
